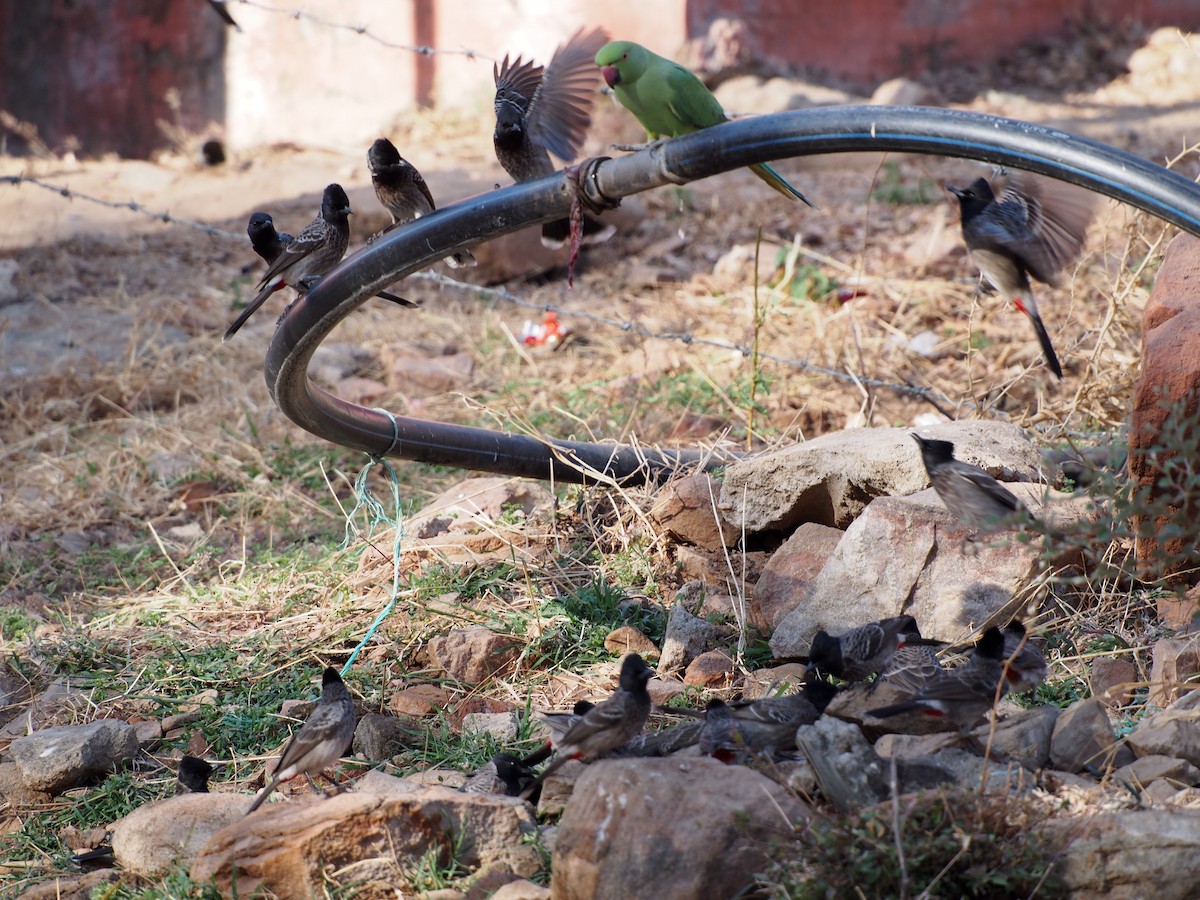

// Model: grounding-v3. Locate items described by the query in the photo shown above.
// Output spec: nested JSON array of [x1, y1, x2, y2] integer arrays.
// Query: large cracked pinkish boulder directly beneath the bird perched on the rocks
[[770, 485, 1060, 656]]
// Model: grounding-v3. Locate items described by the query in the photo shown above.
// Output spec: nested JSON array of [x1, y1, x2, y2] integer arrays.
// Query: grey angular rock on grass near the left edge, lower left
[[8, 719, 139, 794]]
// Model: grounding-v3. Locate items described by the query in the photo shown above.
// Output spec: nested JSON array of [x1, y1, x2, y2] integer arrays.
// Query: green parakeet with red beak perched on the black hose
[[596, 41, 812, 206]]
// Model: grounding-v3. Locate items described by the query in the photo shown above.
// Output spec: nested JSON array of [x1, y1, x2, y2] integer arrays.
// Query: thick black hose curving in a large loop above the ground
[[266, 107, 1200, 484]]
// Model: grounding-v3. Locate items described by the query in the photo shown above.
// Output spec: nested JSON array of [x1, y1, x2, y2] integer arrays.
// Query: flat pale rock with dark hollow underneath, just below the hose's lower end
[[719, 421, 1042, 535]]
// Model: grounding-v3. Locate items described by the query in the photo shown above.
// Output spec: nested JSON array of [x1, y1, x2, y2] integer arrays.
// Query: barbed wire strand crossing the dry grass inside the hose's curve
[[408, 271, 955, 406]]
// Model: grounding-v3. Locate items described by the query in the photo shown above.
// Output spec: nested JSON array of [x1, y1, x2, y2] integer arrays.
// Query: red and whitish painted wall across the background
[[0, 0, 1200, 156]]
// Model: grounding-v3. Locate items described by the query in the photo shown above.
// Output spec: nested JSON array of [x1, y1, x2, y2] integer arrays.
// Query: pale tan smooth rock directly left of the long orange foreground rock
[[113, 793, 253, 877]]
